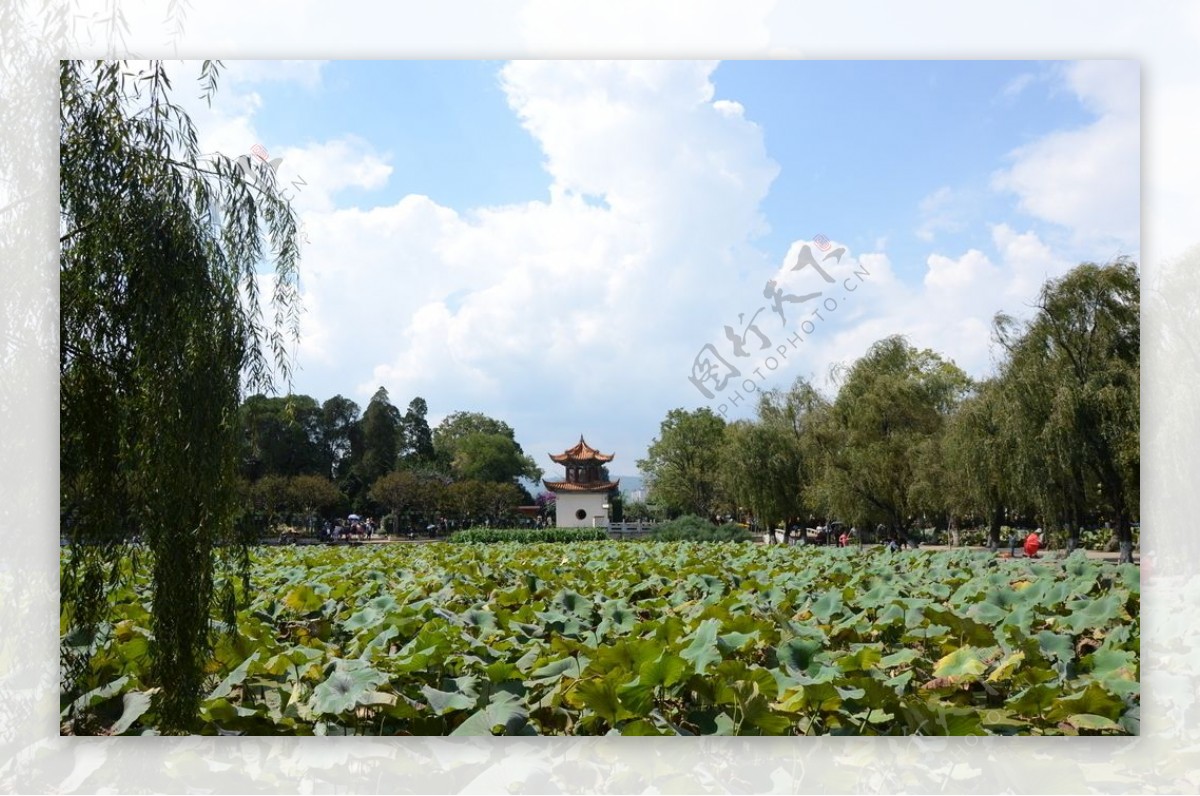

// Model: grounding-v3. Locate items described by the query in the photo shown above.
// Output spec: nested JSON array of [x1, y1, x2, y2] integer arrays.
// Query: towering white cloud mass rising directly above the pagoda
[[279, 61, 778, 468]]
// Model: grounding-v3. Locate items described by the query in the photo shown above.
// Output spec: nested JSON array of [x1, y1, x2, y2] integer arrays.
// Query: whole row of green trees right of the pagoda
[[638, 259, 1141, 562]]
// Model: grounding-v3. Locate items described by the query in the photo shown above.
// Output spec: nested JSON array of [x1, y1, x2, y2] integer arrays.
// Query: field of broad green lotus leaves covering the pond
[[62, 543, 1141, 735]]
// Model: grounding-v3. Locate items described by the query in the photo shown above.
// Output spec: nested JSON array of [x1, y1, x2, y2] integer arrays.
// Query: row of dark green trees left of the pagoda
[[232, 388, 540, 533]]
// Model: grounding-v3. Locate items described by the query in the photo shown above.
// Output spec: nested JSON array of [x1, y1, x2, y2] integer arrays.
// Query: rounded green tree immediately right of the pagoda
[[637, 407, 725, 517]]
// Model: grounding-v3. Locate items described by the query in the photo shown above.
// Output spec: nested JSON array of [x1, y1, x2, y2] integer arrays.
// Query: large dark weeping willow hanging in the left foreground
[[59, 61, 299, 732]]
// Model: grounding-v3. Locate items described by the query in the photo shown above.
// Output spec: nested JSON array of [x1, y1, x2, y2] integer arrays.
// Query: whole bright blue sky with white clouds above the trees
[[177, 61, 1140, 473]]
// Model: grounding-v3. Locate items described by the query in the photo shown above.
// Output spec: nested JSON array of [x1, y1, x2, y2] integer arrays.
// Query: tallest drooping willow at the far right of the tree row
[[996, 259, 1141, 562]]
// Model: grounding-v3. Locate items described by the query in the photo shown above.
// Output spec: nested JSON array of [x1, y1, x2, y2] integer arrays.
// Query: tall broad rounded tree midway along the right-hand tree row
[[808, 336, 970, 533]]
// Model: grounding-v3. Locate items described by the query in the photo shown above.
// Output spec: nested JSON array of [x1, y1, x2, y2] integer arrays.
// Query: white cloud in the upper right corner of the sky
[[992, 61, 1141, 251]]
